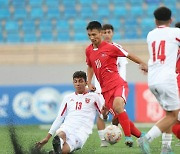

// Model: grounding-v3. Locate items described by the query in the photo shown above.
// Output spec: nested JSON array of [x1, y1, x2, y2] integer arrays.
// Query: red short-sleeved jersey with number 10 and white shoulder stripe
[[86, 41, 128, 92]]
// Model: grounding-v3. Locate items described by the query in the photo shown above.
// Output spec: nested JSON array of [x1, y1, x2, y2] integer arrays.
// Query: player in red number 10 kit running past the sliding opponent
[[86, 21, 147, 147]]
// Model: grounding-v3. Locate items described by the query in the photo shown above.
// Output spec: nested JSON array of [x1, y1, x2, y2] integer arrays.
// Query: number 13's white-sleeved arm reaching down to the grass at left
[[36, 99, 67, 149]]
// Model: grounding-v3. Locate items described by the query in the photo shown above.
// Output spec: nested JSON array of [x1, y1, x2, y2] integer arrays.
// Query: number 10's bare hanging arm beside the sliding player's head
[[87, 65, 96, 91]]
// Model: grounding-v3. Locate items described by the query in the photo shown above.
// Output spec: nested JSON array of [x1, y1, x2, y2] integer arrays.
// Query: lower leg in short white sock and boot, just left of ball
[[97, 117, 109, 147]]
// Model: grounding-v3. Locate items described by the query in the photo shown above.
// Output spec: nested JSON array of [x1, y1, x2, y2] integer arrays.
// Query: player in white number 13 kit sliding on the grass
[[36, 71, 102, 154]]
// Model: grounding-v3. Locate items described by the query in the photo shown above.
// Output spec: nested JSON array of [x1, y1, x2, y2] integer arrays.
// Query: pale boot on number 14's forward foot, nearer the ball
[[137, 136, 151, 154]]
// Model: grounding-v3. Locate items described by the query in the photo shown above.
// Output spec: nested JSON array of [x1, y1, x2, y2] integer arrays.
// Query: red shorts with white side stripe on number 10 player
[[102, 83, 128, 112]]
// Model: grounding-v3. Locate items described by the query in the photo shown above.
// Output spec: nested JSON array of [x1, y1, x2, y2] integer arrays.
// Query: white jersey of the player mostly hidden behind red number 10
[[94, 42, 128, 93]]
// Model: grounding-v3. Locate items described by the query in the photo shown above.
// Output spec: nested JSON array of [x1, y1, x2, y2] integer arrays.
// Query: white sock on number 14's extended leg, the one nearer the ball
[[145, 125, 162, 143]]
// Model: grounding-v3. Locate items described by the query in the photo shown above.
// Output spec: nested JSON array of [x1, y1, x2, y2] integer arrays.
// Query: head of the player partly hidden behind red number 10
[[102, 24, 114, 43]]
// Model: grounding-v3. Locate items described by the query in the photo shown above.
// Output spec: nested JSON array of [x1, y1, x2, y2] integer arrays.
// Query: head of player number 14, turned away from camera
[[154, 6, 172, 25]]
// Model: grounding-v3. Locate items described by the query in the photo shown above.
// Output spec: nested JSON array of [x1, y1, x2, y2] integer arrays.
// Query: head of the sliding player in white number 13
[[73, 71, 87, 94]]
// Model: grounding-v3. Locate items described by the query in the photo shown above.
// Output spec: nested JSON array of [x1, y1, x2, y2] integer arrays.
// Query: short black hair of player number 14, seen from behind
[[154, 6, 171, 21]]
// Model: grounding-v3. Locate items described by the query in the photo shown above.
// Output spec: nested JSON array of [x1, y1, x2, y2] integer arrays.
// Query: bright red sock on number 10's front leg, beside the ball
[[117, 112, 131, 136]]
